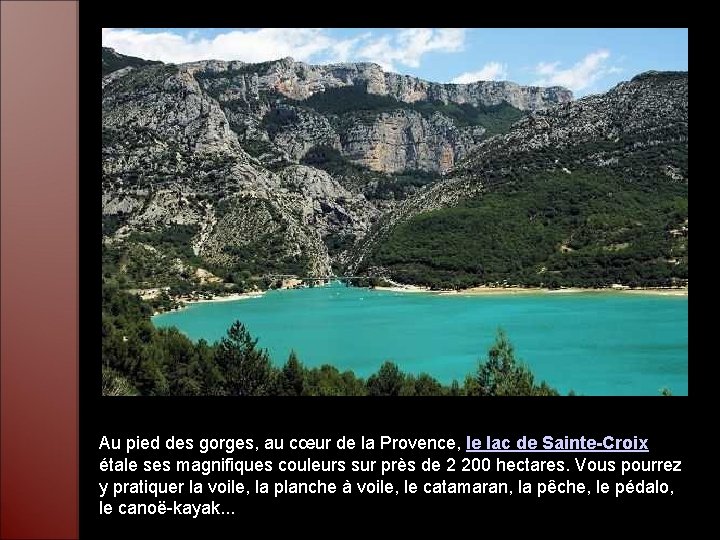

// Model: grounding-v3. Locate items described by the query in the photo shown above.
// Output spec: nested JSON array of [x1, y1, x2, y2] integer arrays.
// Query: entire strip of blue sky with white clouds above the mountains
[[103, 28, 688, 96]]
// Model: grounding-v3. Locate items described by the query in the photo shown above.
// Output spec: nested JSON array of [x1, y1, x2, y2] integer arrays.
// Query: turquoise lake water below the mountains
[[153, 284, 688, 395]]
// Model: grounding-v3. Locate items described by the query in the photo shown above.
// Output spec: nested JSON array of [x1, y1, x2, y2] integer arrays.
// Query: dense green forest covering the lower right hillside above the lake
[[369, 169, 688, 288]]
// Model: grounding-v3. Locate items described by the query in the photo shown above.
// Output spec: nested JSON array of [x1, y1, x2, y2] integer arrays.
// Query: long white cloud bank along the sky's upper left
[[102, 28, 465, 69]]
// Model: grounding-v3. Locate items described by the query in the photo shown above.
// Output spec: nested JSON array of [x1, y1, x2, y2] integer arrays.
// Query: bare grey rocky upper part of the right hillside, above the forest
[[366, 72, 688, 226]]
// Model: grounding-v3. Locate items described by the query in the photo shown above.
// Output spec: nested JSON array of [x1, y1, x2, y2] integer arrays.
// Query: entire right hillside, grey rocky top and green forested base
[[354, 72, 688, 287]]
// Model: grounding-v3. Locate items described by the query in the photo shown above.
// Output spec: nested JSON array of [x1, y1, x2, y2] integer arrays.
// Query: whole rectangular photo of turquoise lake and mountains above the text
[[100, 28, 689, 398]]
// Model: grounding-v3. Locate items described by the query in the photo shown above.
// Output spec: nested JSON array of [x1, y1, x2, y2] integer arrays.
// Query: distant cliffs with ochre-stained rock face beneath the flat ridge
[[188, 58, 572, 173]]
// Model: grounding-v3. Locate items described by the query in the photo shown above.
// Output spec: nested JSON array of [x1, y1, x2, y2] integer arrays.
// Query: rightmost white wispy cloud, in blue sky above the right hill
[[535, 49, 620, 92]]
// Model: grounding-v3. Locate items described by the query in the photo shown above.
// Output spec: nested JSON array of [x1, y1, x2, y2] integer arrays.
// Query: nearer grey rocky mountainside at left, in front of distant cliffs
[[103, 61, 377, 275]]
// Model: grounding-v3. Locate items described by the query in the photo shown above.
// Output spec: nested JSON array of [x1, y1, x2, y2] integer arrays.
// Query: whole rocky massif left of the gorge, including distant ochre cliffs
[[102, 49, 569, 286]]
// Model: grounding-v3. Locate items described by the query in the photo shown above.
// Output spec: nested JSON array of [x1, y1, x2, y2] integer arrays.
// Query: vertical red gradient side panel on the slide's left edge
[[0, 1, 78, 539]]
